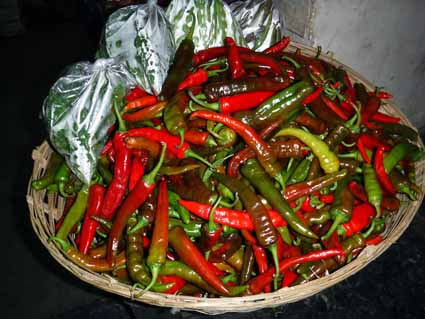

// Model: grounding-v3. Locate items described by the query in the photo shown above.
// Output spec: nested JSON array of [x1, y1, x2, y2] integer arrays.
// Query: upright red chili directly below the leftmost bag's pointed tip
[[78, 184, 105, 254]]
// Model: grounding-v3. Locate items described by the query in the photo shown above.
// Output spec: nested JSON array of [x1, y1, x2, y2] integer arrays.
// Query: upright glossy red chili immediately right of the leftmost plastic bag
[[100, 132, 131, 219]]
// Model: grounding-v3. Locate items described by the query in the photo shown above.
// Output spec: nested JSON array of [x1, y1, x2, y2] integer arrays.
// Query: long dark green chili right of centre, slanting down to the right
[[241, 159, 317, 238]]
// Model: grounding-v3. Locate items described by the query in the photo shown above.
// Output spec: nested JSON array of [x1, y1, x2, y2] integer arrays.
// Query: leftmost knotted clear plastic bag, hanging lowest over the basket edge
[[42, 58, 136, 184]]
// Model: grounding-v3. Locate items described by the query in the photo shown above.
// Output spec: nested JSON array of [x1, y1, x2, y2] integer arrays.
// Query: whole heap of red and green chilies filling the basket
[[33, 36, 423, 297]]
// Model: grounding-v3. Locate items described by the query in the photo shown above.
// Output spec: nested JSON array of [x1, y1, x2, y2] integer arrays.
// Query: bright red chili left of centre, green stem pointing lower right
[[128, 127, 211, 166]]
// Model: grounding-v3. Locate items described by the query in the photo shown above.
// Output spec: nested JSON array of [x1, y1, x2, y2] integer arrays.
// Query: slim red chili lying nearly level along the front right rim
[[248, 249, 344, 295]]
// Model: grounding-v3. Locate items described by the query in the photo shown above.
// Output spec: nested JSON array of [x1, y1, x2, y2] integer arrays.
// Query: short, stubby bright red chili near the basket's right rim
[[338, 202, 376, 237]]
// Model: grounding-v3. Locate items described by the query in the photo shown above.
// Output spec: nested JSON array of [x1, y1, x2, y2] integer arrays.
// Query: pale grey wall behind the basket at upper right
[[312, 0, 425, 135]]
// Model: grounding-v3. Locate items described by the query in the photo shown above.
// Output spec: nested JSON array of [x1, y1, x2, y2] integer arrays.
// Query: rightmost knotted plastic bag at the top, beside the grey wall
[[230, 0, 282, 51]]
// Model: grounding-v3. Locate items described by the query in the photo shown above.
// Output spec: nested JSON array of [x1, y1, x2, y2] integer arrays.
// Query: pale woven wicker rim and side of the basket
[[27, 43, 425, 314]]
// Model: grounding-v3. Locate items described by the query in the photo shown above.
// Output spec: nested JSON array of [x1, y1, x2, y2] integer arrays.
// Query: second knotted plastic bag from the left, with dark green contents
[[100, 0, 176, 95]]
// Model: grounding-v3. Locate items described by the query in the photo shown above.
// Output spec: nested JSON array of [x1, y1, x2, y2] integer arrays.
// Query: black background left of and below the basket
[[0, 1, 425, 319]]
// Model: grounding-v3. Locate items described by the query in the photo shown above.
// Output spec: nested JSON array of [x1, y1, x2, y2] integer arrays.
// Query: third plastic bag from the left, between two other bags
[[166, 0, 245, 51]]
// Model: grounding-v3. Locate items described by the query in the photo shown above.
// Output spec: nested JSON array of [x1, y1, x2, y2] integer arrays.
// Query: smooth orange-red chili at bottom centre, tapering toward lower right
[[168, 226, 229, 295]]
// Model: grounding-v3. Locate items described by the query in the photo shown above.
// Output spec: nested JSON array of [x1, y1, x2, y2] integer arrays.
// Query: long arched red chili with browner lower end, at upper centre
[[190, 111, 280, 184]]
